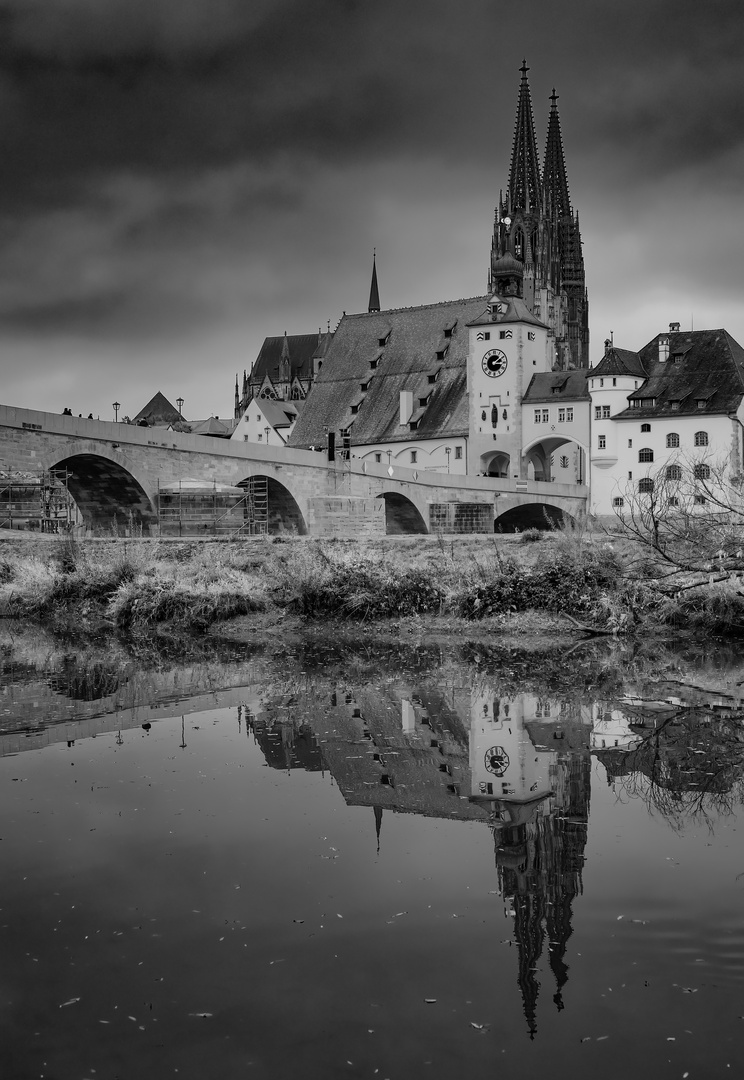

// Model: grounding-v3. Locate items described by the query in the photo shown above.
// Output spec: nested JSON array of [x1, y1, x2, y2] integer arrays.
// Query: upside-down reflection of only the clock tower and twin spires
[[470, 691, 591, 1038]]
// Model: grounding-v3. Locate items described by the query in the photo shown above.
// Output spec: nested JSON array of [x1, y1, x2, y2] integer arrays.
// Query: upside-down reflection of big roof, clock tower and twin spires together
[[252, 684, 591, 1038]]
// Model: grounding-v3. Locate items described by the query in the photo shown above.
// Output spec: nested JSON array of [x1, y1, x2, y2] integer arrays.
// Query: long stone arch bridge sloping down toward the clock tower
[[0, 405, 587, 536]]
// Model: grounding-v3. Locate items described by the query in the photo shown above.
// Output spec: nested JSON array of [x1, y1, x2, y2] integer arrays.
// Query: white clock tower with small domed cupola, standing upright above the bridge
[[468, 270, 552, 480]]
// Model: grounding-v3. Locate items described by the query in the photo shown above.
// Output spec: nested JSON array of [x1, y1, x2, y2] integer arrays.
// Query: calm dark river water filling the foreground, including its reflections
[[0, 625, 744, 1080]]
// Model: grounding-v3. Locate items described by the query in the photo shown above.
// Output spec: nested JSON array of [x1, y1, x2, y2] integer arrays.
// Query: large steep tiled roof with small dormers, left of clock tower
[[289, 296, 487, 447]]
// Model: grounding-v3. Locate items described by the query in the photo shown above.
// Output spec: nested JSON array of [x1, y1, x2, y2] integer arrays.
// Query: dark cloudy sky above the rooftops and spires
[[0, 0, 744, 418]]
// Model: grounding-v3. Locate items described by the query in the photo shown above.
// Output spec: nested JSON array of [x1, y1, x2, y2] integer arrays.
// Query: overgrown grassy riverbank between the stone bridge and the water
[[0, 530, 744, 638]]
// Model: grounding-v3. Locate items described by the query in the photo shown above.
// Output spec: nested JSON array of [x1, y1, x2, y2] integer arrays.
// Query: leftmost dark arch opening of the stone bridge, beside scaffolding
[[43, 444, 158, 536]]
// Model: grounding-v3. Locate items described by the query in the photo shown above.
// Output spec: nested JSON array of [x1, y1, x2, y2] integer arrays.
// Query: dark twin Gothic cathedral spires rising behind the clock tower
[[488, 63, 589, 369]]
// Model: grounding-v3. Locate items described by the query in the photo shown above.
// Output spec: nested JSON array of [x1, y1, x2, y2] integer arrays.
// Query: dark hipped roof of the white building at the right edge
[[613, 329, 744, 419]]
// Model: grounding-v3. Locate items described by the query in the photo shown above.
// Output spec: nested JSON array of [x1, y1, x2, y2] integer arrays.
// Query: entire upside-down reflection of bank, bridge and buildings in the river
[[0, 622, 744, 1067]]
